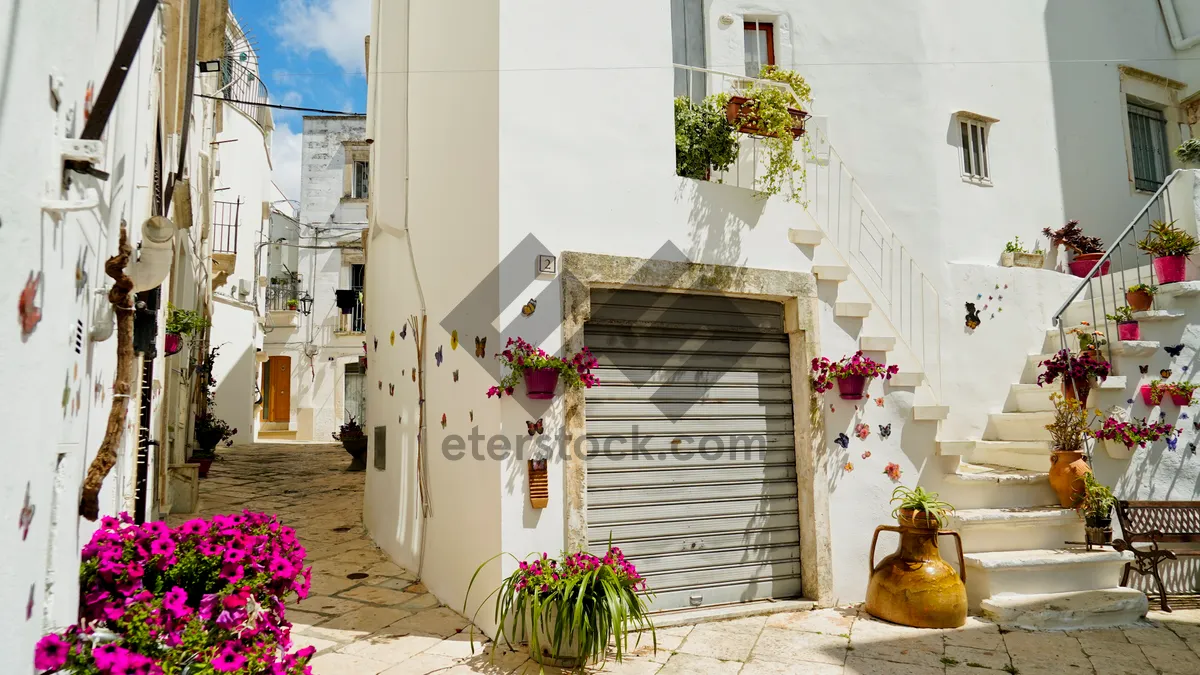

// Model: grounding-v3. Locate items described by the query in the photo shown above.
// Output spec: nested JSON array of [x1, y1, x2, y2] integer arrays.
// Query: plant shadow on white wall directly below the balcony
[[676, 179, 767, 265]]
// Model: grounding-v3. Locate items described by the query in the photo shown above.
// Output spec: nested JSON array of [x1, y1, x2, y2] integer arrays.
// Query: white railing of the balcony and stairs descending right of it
[[674, 65, 941, 395]]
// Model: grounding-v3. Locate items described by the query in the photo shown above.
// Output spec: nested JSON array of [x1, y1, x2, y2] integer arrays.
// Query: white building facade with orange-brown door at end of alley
[[259, 115, 370, 441]]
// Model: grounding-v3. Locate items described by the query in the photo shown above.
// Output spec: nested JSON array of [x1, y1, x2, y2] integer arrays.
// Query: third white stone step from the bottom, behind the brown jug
[[942, 506, 1084, 552]]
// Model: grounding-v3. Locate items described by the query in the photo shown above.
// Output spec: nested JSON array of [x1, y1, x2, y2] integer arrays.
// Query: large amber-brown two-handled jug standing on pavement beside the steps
[[865, 513, 967, 628]]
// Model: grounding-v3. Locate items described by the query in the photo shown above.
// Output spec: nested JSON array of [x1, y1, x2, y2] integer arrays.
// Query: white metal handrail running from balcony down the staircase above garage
[[674, 64, 942, 395]]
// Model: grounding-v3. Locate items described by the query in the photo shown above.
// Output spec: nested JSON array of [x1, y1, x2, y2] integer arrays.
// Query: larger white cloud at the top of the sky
[[271, 0, 371, 72]]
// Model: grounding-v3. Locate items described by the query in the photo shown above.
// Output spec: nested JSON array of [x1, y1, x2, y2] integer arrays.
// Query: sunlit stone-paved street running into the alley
[[172, 443, 1200, 675]]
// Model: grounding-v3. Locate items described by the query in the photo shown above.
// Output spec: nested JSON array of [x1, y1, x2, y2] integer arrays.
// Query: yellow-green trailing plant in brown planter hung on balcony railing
[[716, 65, 812, 202]]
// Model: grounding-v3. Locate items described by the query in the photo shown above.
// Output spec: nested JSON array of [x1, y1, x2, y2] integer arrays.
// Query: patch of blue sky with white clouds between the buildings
[[229, 0, 371, 199]]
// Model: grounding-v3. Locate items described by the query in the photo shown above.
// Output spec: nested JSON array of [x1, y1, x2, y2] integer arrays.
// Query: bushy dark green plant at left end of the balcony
[[674, 95, 740, 180]]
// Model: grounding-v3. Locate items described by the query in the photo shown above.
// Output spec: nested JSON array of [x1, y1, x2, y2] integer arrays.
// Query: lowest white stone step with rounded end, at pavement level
[[979, 587, 1150, 631]]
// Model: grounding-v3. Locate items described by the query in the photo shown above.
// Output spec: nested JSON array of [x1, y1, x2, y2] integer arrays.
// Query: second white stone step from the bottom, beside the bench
[[964, 548, 1133, 610]]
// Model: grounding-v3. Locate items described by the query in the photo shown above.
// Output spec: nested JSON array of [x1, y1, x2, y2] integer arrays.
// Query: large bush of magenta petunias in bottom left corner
[[35, 512, 313, 675]]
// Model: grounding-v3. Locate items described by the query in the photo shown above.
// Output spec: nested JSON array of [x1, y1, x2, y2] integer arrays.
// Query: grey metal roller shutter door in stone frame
[[584, 289, 800, 610]]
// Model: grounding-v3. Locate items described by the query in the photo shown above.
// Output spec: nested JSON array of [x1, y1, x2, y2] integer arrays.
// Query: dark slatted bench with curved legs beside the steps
[[1112, 501, 1200, 611]]
